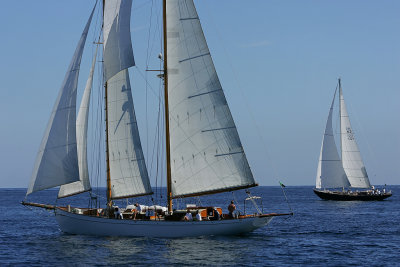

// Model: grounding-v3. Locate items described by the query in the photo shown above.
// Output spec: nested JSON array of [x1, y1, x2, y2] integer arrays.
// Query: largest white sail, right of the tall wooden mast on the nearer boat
[[166, 0, 256, 197]]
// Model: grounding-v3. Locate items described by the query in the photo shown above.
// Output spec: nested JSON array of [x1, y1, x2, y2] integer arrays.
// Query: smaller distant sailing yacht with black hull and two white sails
[[314, 79, 392, 200]]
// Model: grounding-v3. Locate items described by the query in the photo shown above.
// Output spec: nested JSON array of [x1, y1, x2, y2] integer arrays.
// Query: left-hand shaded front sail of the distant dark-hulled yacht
[[315, 91, 350, 188]]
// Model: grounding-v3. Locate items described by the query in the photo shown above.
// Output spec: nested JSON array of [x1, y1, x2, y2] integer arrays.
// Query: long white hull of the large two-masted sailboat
[[55, 209, 274, 237]]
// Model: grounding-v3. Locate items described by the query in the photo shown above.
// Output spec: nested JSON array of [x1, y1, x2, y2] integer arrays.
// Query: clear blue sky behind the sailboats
[[0, 0, 400, 187]]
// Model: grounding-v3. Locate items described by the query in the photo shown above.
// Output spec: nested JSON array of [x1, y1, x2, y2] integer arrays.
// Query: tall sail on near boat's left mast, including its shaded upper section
[[103, 0, 152, 199]]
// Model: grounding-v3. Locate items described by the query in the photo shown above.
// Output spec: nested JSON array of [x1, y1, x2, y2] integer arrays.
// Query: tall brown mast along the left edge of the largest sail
[[163, 0, 172, 213]]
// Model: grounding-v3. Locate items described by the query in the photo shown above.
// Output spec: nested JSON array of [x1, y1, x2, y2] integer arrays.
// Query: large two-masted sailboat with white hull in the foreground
[[23, 0, 290, 237]]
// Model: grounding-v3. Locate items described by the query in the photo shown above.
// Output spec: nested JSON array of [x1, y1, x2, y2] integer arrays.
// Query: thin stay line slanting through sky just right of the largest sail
[[207, 4, 278, 182]]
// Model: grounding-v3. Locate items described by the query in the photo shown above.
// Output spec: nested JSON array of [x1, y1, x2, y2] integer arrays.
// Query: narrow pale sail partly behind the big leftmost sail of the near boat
[[58, 48, 97, 198]]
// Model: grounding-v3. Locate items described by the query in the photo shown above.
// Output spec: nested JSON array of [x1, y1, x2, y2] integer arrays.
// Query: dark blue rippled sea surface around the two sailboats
[[0, 186, 400, 266]]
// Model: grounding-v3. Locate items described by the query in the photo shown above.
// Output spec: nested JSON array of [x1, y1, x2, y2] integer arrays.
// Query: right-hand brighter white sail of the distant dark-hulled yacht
[[339, 80, 371, 188]]
